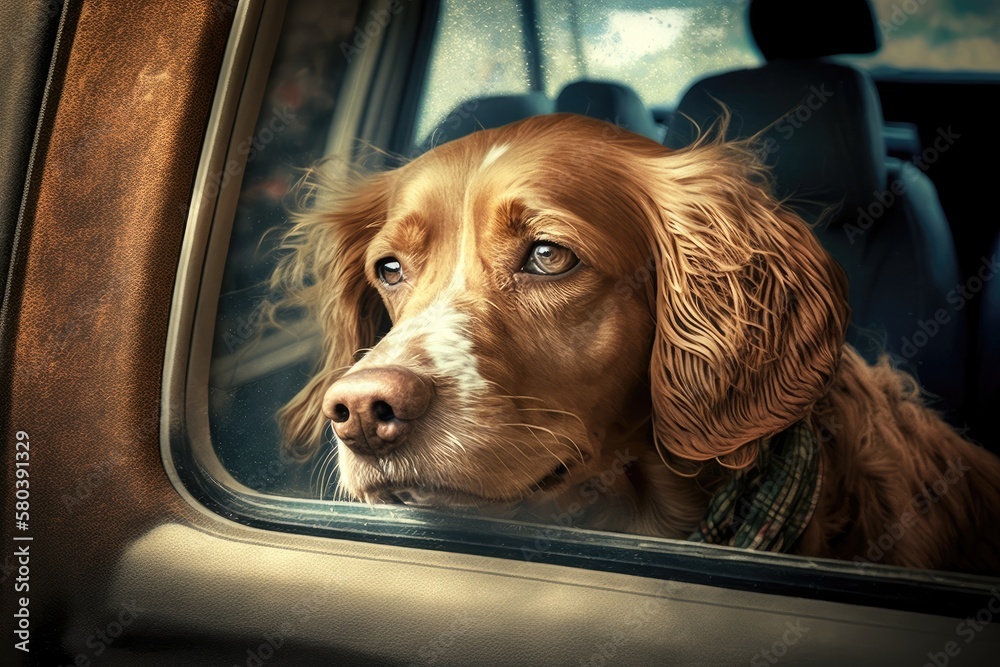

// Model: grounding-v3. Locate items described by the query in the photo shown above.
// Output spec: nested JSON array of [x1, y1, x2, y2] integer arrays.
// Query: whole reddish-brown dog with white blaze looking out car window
[[272, 114, 1000, 573]]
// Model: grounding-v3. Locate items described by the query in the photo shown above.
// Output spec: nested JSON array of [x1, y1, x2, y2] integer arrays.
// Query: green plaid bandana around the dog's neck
[[689, 422, 822, 552]]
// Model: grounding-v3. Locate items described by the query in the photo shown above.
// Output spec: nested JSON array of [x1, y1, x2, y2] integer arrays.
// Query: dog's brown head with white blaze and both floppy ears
[[278, 115, 848, 516]]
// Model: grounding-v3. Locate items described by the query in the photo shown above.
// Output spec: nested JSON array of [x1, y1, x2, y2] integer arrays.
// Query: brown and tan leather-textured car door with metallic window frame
[[0, 0, 1000, 667]]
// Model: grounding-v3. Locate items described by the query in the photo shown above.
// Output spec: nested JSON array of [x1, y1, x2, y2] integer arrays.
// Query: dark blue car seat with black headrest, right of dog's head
[[666, 0, 967, 416]]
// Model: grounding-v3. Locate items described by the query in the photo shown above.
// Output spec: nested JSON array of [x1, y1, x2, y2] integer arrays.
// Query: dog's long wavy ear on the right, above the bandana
[[646, 140, 850, 468]]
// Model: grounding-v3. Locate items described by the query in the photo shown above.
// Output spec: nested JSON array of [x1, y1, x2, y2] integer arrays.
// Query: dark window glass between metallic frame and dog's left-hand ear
[[207, 0, 364, 495]]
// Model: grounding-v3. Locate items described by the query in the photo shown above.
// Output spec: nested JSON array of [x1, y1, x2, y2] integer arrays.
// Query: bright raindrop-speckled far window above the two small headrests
[[414, 0, 760, 146]]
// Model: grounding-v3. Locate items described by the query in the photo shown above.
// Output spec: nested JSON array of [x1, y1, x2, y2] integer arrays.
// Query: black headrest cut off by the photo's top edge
[[749, 0, 880, 60]]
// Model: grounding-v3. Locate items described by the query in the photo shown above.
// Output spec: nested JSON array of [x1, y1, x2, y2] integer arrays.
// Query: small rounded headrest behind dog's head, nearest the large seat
[[556, 81, 663, 141]]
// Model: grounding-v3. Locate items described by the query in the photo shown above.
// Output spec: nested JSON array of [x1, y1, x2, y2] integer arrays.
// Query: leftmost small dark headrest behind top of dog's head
[[421, 91, 555, 150]]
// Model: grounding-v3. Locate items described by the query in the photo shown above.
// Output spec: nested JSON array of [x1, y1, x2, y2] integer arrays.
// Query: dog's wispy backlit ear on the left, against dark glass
[[271, 164, 391, 460]]
